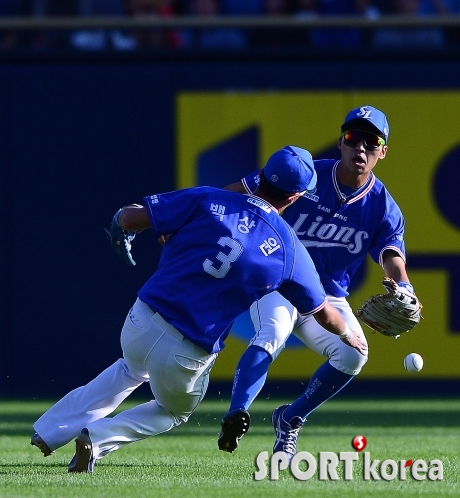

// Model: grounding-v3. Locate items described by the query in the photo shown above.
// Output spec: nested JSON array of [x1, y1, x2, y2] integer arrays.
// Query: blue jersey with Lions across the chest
[[242, 159, 405, 297]]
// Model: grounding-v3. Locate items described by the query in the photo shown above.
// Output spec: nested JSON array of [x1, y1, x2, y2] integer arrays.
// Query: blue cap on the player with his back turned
[[263, 145, 316, 194]]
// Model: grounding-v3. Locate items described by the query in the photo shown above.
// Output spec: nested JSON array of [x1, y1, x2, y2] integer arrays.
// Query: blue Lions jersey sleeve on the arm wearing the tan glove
[[369, 194, 406, 266]]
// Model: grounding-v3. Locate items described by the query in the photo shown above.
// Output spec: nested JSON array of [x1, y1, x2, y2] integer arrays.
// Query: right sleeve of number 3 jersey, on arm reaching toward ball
[[278, 239, 327, 315]]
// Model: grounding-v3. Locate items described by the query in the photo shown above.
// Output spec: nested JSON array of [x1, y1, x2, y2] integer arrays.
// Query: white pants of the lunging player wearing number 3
[[34, 299, 217, 459]]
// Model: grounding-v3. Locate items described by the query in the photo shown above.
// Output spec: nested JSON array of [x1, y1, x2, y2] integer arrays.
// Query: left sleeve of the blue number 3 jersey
[[144, 187, 207, 237]]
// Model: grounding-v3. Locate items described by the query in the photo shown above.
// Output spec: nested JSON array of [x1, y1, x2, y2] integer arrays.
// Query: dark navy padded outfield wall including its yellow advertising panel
[[0, 54, 460, 397]]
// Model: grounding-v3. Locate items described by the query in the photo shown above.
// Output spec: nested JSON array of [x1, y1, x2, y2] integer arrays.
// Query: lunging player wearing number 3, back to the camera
[[31, 147, 367, 472]]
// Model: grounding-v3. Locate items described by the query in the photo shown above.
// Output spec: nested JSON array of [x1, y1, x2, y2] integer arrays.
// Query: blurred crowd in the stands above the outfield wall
[[0, 0, 460, 52]]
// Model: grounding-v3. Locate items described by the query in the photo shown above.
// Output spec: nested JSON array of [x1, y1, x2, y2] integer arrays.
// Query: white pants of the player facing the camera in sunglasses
[[246, 292, 367, 375]]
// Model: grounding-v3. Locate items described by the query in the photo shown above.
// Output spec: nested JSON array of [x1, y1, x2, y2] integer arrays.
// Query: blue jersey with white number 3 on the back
[[138, 187, 326, 353]]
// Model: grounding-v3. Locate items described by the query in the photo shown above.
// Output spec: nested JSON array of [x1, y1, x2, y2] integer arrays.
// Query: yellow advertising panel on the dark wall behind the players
[[176, 91, 460, 380]]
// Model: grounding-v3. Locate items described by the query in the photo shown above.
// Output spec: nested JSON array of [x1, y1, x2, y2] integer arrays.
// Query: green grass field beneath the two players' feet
[[0, 399, 460, 498]]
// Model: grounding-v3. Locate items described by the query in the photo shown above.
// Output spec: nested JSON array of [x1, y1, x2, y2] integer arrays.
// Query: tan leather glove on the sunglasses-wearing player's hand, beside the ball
[[356, 277, 423, 339]]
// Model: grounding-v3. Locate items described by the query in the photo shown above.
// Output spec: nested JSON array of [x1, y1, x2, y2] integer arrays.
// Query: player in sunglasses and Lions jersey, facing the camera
[[218, 106, 422, 458]]
